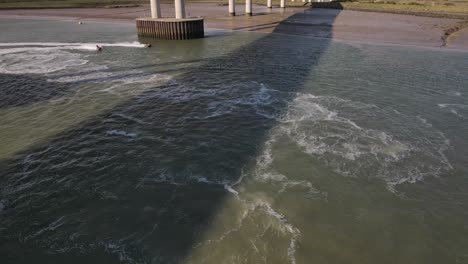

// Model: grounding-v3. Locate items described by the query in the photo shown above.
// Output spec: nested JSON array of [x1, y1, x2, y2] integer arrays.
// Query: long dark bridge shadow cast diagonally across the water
[[0, 5, 338, 264]]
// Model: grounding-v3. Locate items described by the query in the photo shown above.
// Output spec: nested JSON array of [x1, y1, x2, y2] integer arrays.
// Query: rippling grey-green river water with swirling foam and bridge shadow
[[0, 19, 468, 263]]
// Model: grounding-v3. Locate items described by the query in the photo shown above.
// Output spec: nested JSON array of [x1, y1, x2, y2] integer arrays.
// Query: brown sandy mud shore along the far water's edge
[[0, 3, 468, 50]]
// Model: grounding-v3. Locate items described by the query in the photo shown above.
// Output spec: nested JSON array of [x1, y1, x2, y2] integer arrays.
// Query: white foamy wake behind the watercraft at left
[[0, 42, 150, 84]]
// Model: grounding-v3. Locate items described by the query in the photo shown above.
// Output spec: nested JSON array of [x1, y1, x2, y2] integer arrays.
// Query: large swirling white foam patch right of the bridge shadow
[[255, 93, 452, 192]]
